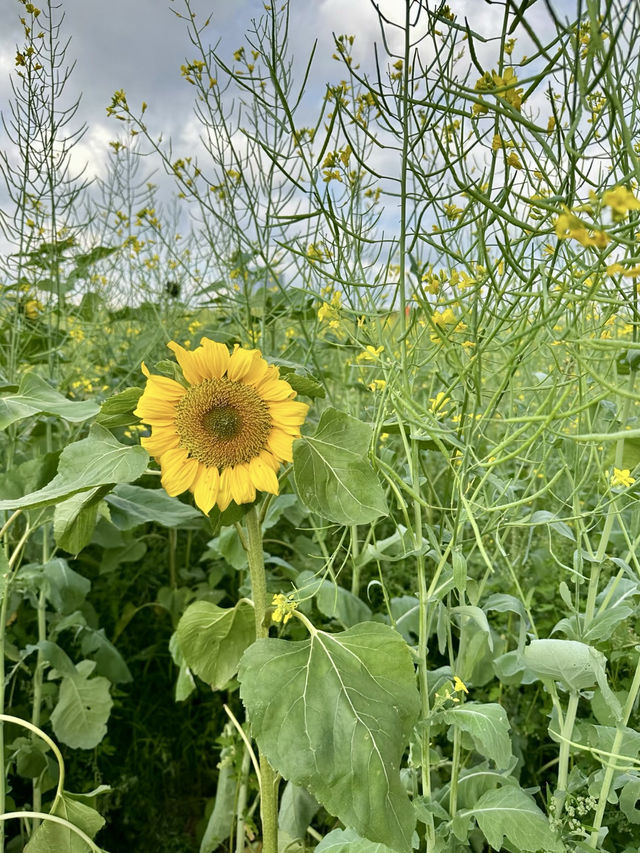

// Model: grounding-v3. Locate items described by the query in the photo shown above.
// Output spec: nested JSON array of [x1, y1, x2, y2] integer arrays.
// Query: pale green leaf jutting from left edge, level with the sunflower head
[[0, 373, 99, 429]]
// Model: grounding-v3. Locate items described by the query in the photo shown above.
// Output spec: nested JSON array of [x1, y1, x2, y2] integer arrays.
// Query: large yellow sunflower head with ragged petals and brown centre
[[135, 338, 309, 514]]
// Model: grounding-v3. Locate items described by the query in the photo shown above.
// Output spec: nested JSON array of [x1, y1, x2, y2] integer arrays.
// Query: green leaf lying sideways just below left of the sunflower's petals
[[106, 483, 205, 530]]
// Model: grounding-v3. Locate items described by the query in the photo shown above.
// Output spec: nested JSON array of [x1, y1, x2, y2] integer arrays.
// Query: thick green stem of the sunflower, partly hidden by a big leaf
[[245, 505, 278, 853]]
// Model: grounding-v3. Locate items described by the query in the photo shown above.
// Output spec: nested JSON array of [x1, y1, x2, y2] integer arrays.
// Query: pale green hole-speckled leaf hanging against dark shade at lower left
[[51, 661, 113, 749]]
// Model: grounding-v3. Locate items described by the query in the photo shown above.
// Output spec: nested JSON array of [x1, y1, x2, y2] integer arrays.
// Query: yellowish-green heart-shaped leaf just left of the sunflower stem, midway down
[[176, 601, 256, 690]]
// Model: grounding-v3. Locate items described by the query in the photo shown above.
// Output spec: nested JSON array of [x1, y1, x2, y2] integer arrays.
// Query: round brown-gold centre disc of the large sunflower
[[175, 379, 272, 468]]
